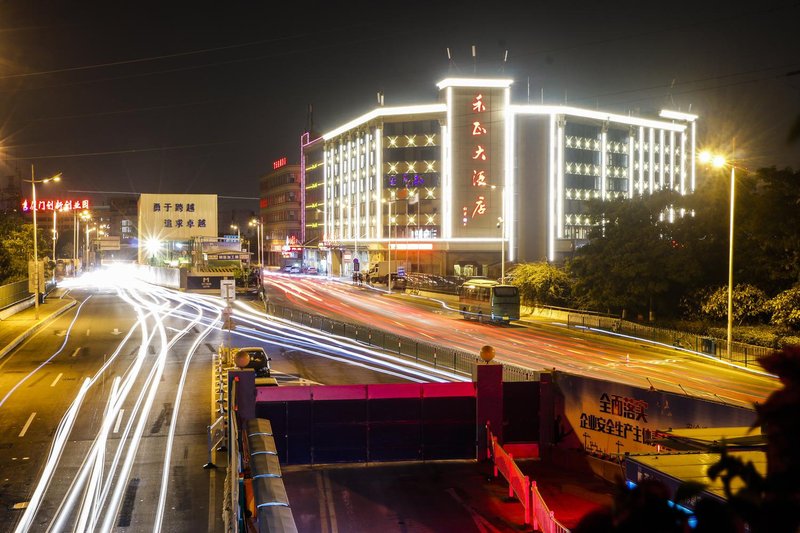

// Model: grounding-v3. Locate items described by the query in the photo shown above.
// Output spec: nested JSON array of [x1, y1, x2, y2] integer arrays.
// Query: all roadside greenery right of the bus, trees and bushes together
[[510, 167, 800, 347]]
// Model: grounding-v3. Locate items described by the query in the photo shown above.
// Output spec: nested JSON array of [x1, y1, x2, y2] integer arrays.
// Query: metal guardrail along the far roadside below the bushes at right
[[567, 313, 773, 367]]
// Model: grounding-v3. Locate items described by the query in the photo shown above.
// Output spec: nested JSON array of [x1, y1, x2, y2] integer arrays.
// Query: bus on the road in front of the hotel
[[458, 279, 519, 324]]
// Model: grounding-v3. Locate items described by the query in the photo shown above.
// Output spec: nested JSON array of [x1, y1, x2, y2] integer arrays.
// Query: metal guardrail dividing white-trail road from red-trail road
[[267, 302, 539, 381]]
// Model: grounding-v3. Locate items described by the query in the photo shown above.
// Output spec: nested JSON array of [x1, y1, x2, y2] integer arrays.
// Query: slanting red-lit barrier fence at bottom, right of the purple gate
[[486, 423, 570, 533]]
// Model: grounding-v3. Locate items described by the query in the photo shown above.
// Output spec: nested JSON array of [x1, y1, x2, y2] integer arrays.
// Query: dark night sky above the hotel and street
[[0, 0, 800, 209]]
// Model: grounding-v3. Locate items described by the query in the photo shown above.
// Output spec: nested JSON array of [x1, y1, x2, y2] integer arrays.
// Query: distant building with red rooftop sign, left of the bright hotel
[[259, 157, 303, 267]]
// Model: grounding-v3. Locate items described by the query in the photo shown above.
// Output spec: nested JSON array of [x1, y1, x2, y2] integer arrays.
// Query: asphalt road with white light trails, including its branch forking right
[[0, 277, 464, 531]]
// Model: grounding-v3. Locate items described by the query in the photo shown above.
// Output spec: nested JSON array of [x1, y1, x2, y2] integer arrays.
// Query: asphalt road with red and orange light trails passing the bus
[[266, 274, 780, 407]]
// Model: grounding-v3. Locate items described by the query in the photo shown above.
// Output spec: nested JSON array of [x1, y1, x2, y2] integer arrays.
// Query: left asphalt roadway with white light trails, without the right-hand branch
[[0, 280, 224, 531]]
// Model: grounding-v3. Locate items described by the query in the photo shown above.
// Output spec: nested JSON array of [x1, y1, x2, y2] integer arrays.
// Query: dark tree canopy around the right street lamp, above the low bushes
[[569, 168, 800, 317]]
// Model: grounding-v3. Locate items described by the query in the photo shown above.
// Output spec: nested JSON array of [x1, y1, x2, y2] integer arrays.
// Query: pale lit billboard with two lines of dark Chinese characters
[[139, 194, 218, 241]]
